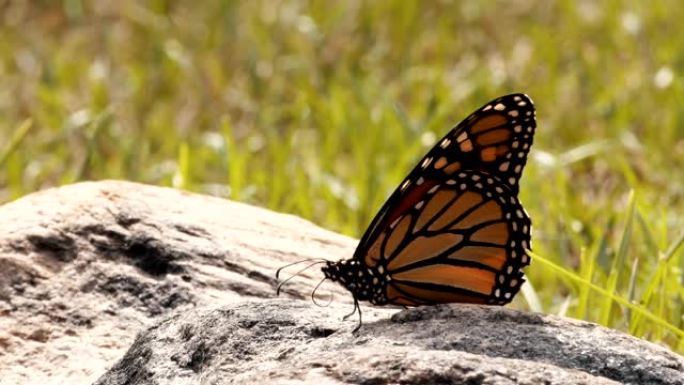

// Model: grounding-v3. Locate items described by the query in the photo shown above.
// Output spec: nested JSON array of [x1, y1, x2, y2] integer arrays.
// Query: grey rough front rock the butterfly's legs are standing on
[[96, 300, 684, 385]]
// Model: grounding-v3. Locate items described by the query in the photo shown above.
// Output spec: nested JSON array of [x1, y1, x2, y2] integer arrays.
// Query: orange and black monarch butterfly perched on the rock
[[276, 94, 536, 331]]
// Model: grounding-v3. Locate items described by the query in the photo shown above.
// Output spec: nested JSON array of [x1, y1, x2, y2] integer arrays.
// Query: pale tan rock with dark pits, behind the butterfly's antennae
[[0, 181, 356, 385]]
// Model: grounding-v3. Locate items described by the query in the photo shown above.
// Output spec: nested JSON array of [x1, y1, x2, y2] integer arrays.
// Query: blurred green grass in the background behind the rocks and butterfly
[[0, 0, 684, 352]]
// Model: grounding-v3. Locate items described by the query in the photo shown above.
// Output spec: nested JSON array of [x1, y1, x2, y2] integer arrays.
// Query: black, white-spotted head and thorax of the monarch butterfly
[[321, 259, 384, 304]]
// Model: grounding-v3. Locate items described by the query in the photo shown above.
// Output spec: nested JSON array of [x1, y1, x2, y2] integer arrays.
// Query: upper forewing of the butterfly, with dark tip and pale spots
[[354, 94, 536, 261]]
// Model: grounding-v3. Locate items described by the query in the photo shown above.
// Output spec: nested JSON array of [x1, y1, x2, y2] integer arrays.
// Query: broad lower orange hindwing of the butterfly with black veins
[[363, 171, 531, 305]]
